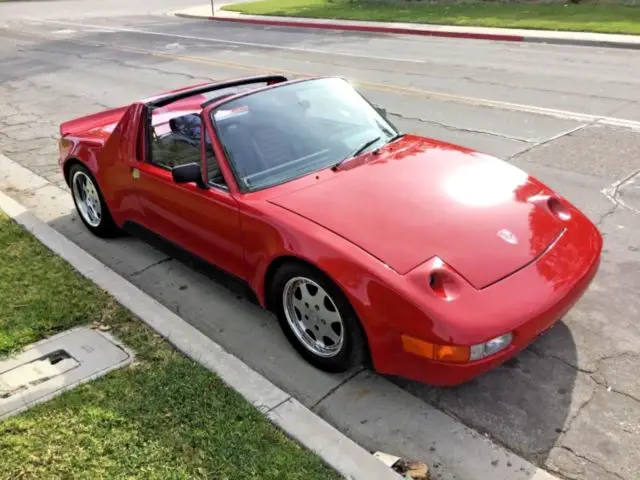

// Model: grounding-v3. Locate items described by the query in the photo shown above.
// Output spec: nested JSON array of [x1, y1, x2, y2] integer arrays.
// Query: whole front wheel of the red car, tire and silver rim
[[270, 263, 367, 373]]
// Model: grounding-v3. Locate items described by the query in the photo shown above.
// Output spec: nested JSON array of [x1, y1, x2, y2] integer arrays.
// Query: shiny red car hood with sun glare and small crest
[[269, 136, 563, 288]]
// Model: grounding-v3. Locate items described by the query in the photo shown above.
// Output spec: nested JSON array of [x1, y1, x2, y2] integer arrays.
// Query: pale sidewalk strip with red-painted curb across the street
[[169, 4, 640, 49]]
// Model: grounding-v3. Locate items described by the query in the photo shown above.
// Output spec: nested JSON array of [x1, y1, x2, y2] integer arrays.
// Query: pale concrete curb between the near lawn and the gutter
[[0, 163, 401, 480]]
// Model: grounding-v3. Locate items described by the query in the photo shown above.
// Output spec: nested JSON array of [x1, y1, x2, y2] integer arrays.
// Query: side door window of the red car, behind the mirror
[[151, 113, 201, 170]]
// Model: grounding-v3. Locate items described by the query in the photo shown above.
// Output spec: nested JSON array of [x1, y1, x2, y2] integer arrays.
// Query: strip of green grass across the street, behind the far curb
[[224, 0, 640, 34]]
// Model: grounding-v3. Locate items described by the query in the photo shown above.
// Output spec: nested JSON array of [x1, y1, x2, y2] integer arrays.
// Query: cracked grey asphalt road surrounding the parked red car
[[0, 4, 640, 480]]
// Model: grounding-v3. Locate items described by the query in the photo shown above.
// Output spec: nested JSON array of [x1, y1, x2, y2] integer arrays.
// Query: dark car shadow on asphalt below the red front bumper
[[390, 321, 589, 466]]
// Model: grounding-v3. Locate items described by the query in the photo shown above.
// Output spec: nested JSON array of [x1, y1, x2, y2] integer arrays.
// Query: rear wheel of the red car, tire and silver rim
[[69, 164, 121, 238]]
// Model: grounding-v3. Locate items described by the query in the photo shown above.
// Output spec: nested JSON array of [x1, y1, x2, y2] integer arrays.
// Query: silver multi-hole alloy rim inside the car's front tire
[[282, 277, 344, 358]]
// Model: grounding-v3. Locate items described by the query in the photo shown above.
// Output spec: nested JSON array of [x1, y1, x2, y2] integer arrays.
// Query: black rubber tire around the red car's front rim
[[269, 262, 369, 373]]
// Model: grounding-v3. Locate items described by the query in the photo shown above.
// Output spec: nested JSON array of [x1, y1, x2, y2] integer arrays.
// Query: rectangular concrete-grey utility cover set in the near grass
[[0, 327, 134, 420]]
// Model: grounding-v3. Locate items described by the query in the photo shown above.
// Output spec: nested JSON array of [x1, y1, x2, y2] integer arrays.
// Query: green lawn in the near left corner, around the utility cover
[[0, 215, 339, 480]]
